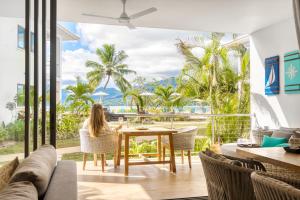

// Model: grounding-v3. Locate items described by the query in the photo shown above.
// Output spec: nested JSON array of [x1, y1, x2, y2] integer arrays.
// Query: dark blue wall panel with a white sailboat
[[265, 56, 280, 95]]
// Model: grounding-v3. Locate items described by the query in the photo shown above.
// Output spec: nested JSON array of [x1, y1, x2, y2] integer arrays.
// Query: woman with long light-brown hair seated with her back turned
[[82, 103, 122, 137]]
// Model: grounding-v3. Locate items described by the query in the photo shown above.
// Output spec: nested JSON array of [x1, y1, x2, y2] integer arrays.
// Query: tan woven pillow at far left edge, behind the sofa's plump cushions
[[0, 157, 19, 191]]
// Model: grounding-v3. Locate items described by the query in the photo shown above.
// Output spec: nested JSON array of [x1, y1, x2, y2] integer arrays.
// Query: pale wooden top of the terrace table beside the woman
[[120, 127, 177, 135]]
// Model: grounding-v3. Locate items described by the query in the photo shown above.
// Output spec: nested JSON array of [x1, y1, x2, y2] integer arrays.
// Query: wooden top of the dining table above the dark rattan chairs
[[236, 147, 300, 172]]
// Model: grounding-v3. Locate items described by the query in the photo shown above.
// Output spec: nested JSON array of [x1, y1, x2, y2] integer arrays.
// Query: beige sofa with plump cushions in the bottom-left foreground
[[0, 145, 77, 200]]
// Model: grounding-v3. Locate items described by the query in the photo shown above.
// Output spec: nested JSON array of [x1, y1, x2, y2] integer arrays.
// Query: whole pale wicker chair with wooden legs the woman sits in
[[79, 129, 117, 172]]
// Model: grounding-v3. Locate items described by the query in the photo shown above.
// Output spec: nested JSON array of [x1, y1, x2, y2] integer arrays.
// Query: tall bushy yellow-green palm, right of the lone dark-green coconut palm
[[177, 33, 232, 113]]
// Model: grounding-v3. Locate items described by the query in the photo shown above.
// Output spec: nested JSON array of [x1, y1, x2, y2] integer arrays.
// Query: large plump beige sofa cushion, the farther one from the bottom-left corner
[[10, 145, 57, 197]]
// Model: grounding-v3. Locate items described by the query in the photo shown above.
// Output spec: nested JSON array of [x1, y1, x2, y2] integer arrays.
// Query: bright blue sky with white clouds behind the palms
[[60, 22, 234, 87]]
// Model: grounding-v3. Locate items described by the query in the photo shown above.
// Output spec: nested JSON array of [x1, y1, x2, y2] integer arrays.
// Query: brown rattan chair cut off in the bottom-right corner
[[251, 172, 300, 200]]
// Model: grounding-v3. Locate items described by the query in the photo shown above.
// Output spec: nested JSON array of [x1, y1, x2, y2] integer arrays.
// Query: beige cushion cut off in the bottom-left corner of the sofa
[[0, 181, 38, 200]]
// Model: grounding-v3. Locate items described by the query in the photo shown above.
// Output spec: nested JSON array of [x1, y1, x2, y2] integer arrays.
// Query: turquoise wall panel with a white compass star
[[284, 51, 300, 94]]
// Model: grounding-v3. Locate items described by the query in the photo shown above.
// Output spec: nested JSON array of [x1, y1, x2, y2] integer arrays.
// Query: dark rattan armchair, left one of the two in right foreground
[[199, 152, 265, 200]]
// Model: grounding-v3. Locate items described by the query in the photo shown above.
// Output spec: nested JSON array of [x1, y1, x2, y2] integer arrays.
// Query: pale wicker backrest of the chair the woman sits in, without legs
[[79, 129, 116, 154]]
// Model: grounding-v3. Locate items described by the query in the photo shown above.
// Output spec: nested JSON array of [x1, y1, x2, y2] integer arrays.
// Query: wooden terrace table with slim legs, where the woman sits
[[117, 128, 177, 176]]
